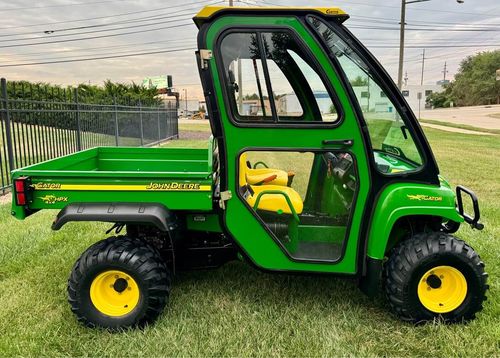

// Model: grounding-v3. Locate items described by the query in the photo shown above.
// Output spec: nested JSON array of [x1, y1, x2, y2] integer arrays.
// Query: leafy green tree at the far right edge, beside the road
[[451, 50, 500, 106]]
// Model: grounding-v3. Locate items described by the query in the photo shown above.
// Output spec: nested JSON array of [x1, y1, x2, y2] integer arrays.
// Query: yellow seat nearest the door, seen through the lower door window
[[239, 153, 304, 214]]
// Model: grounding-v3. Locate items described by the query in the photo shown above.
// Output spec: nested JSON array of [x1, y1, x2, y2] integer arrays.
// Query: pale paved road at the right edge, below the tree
[[420, 105, 500, 129]]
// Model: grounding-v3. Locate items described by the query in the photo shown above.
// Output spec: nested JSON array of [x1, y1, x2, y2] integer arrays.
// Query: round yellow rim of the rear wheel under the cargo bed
[[90, 270, 140, 317]]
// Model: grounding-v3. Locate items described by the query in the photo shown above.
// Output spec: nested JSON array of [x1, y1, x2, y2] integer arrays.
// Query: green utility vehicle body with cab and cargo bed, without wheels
[[12, 10, 480, 293]]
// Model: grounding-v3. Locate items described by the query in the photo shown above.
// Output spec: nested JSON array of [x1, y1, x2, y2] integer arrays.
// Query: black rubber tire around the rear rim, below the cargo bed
[[68, 236, 171, 330]]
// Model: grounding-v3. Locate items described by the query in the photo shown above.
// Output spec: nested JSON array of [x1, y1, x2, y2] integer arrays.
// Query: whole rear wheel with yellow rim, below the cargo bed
[[68, 236, 170, 329]]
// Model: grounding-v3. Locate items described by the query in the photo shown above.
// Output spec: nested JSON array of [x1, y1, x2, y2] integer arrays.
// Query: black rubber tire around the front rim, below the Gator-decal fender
[[384, 232, 488, 323]]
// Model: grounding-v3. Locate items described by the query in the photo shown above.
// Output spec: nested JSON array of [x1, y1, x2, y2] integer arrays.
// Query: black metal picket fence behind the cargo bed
[[0, 78, 179, 194]]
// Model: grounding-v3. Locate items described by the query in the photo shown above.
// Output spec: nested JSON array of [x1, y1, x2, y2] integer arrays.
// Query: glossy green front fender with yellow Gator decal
[[367, 183, 464, 260]]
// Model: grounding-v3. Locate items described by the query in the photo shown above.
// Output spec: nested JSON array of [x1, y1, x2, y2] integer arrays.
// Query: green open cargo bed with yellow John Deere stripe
[[12, 141, 214, 219]]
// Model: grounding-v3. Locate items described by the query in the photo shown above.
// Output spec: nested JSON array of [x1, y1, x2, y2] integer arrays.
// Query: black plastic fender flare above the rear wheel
[[52, 203, 177, 232]]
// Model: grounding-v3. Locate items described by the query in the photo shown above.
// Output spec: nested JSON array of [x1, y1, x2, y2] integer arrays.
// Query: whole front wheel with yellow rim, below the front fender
[[385, 233, 488, 323]]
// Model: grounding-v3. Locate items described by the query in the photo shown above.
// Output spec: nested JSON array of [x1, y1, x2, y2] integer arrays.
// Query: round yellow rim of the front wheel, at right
[[418, 266, 467, 313]]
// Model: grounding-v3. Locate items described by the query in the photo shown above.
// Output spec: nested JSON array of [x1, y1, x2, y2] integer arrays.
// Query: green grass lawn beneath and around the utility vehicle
[[0, 126, 500, 357]]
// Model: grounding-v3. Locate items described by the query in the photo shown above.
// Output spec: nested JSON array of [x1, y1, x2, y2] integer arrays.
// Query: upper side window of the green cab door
[[221, 31, 338, 123]]
